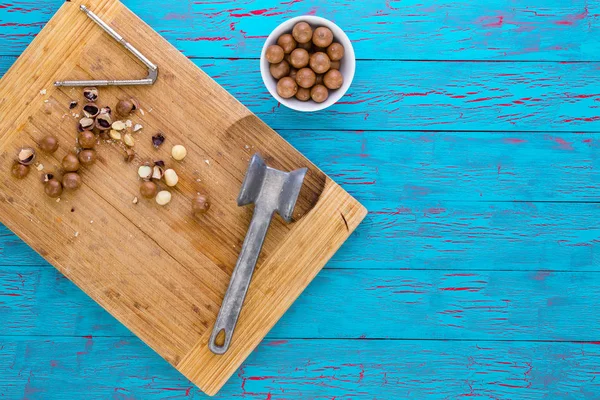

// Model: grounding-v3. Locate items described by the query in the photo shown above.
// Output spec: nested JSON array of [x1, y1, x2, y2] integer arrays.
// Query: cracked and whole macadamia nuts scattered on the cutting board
[[11, 87, 210, 220]]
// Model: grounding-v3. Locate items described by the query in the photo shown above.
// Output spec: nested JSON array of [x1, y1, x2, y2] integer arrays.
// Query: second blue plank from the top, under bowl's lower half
[[2, 57, 600, 132]]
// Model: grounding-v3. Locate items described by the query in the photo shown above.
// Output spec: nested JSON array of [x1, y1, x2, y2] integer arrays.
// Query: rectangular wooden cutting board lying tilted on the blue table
[[0, 0, 366, 395]]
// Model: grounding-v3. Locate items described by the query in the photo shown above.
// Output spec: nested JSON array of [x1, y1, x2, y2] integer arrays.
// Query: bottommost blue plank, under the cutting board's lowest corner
[[0, 337, 600, 400]]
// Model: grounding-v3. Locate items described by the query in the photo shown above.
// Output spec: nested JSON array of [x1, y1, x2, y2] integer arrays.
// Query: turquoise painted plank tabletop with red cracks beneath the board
[[0, 0, 600, 399]]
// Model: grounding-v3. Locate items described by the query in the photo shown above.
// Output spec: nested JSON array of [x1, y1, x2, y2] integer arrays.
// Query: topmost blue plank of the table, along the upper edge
[[0, 0, 600, 61]]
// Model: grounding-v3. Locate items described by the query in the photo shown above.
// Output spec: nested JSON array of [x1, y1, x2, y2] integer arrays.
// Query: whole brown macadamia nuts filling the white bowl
[[266, 22, 344, 103]]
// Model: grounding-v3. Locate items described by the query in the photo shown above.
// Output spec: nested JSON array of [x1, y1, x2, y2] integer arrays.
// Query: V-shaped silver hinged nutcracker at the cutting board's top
[[54, 5, 158, 86]]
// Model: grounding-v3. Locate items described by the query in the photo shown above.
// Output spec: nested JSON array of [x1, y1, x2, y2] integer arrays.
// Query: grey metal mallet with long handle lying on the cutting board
[[208, 154, 308, 354]]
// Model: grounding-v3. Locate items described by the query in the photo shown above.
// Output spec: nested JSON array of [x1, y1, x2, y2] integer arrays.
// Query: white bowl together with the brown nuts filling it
[[260, 15, 356, 112]]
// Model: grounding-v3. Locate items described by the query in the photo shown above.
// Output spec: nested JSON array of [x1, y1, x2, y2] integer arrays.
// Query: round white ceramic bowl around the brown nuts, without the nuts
[[260, 15, 356, 112]]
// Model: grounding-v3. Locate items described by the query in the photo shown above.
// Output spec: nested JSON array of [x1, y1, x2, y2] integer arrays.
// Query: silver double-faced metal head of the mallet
[[237, 153, 308, 222]]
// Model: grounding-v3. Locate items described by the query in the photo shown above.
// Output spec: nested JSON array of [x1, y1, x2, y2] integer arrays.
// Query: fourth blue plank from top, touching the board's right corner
[[0, 198, 600, 271]]
